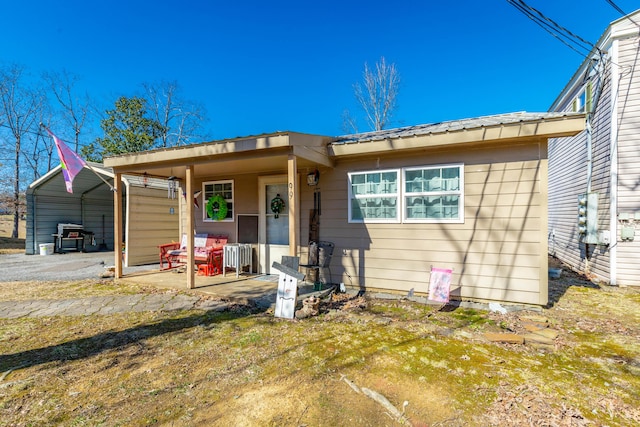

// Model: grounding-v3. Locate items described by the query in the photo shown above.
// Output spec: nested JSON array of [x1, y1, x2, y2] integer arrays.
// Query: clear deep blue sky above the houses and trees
[[0, 0, 640, 139]]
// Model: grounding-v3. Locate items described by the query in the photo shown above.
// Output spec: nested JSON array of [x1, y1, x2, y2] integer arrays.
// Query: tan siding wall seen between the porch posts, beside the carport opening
[[125, 186, 180, 266]]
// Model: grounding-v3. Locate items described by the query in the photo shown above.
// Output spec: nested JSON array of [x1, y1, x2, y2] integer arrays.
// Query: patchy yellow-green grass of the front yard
[[0, 272, 640, 426]]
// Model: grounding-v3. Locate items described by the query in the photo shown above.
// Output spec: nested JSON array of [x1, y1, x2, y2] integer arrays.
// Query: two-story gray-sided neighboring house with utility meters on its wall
[[548, 7, 640, 286]]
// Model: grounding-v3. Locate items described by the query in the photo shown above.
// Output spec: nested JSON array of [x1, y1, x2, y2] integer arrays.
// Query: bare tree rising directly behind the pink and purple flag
[[42, 70, 91, 152]]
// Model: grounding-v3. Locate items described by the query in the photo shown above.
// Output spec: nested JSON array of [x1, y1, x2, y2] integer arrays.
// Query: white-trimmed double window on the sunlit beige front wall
[[348, 164, 464, 223]]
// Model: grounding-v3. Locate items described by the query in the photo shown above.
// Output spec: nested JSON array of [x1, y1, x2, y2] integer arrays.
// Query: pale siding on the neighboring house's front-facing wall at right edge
[[617, 37, 640, 286]]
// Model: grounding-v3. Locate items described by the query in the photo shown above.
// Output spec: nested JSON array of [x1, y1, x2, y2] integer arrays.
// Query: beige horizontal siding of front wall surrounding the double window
[[301, 142, 547, 304]]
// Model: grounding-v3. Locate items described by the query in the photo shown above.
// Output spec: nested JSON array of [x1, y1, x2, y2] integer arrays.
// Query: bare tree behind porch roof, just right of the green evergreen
[[142, 81, 206, 147]]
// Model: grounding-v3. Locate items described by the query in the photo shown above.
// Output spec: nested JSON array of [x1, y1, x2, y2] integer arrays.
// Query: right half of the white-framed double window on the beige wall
[[402, 165, 463, 222]]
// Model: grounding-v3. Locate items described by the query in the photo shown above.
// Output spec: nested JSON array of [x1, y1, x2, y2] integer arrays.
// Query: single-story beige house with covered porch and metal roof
[[105, 112, 585, 305]]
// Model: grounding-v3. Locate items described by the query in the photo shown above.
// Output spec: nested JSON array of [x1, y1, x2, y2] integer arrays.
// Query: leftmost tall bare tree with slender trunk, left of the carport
[[0, 65, 44, 238]]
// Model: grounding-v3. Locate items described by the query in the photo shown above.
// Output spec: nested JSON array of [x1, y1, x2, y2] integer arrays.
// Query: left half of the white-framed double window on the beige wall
[[349, 169, 400, 222]]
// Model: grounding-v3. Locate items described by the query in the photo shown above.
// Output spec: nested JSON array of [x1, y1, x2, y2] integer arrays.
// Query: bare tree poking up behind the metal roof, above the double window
[[353, 57, 400, 130]]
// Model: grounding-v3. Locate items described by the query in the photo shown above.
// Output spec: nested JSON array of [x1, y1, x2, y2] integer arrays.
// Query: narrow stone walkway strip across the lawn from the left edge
[[0, 294, 229, 319]]
